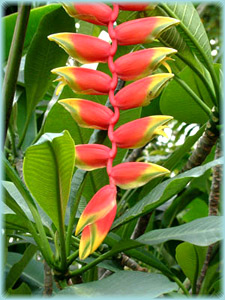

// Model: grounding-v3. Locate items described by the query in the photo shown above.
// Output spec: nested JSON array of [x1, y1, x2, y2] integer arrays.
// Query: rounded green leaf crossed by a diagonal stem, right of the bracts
[[160, 66, 212, 124]]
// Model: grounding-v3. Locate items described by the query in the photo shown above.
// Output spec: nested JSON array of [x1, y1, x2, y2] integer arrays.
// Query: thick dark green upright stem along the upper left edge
[[2, 4, 31, 141]]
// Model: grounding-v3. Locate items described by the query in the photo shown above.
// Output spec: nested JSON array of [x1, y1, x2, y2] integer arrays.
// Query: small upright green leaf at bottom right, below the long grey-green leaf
[[176, 242, 207, 287]]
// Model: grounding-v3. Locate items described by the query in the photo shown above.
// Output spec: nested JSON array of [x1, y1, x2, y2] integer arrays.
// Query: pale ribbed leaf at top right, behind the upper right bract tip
[[162, 2, 212, 63]]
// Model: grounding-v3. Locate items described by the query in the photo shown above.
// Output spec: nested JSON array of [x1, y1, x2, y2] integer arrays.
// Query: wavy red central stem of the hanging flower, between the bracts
[[107, 4, 120, 186]]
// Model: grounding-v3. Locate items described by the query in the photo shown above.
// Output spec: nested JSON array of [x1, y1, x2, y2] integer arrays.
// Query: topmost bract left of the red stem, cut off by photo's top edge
[[63, 3, 112, 25]]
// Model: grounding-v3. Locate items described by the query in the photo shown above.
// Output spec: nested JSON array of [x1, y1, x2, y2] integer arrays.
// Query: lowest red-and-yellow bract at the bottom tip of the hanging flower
[[79, 205, 116, 259]]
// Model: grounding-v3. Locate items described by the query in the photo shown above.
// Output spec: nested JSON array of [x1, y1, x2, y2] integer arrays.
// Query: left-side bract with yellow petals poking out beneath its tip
[[52, 67, 111, 95]]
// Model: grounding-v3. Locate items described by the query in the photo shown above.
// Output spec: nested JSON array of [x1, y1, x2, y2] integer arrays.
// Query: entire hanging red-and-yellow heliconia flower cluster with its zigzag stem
[[49, 3, 179, 259]]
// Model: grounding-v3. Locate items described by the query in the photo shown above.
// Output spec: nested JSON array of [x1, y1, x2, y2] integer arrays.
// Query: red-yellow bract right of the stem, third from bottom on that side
[[115, 73, 174, 110]]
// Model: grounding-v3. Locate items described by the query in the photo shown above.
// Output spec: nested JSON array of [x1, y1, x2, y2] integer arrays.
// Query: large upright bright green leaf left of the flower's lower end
[[24, 131, 75, 228]]
